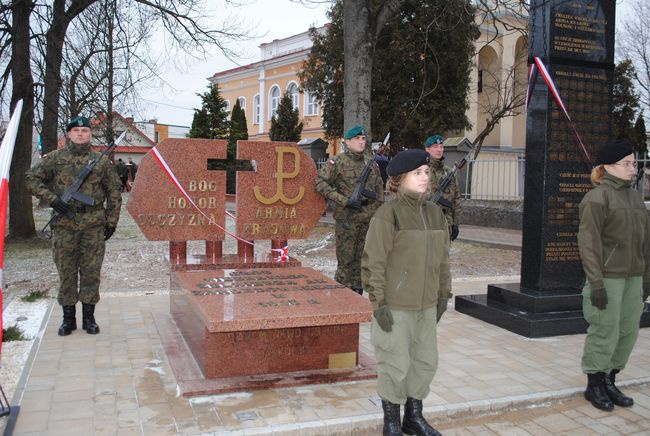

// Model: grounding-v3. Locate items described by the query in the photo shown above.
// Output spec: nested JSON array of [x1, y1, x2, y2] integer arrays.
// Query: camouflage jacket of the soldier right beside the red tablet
[[316, 151, 384, 223]]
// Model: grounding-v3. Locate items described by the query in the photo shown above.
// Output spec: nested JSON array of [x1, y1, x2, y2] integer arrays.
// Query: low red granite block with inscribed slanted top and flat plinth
[[156, 265, 376, 396]]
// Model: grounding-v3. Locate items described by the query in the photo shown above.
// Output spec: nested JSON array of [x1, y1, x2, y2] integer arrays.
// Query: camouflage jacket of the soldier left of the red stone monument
[[25, 141, 122, 229]]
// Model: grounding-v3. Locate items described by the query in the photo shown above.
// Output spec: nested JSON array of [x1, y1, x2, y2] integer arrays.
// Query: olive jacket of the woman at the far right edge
[[578, 173, 650, 289]]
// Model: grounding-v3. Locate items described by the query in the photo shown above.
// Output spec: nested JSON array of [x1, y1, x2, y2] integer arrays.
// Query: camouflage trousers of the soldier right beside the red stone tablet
[[334, 220, 369, 289]]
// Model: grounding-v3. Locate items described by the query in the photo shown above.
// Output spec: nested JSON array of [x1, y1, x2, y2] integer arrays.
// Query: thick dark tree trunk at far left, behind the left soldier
[[9, 0, 36, 238]]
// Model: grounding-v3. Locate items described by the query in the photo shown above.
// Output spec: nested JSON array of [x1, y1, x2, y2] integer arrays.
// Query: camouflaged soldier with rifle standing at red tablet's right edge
[[316, 126, 384, 294]]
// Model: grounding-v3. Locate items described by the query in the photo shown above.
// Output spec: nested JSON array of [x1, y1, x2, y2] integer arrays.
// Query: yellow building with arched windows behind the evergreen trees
[[209, 9, 528, 186]]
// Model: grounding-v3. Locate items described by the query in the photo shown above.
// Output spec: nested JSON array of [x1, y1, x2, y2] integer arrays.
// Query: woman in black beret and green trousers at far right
[[578, 141, 650, 410]]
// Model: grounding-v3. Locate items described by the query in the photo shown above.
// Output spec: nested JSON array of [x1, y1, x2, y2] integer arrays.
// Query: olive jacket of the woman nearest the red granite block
[[361, 193, 451, 310]]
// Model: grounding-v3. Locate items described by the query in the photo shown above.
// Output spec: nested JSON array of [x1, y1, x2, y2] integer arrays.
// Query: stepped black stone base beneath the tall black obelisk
[[455, 283, 650, 338]]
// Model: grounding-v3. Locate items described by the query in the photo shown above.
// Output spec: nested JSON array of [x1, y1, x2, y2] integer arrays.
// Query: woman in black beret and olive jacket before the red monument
[[361, 149, 451, 435]]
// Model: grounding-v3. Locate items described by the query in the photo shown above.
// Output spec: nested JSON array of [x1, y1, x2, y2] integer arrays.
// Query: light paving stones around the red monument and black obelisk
[[6, 278, 650, 435]]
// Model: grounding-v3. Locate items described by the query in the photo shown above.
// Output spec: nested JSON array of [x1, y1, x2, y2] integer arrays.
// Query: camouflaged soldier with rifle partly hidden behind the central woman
[[424, 135, 461, 241]]
